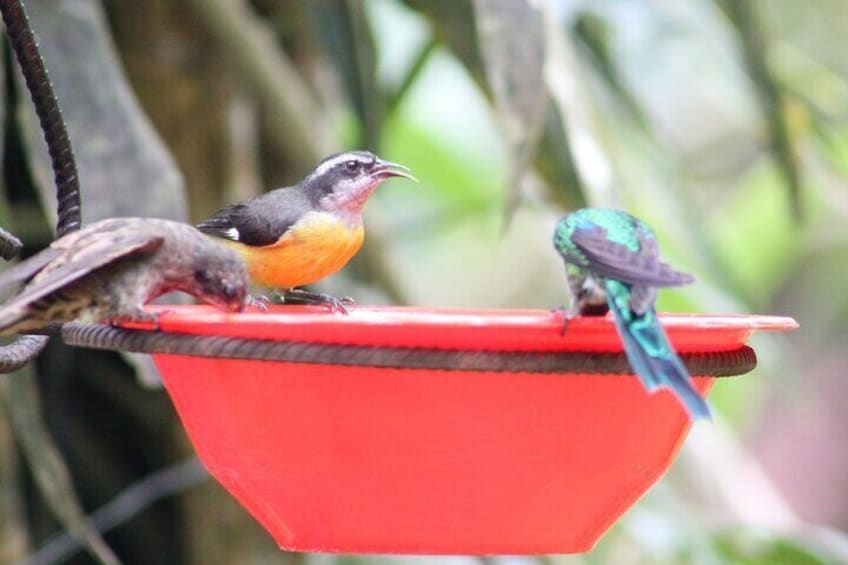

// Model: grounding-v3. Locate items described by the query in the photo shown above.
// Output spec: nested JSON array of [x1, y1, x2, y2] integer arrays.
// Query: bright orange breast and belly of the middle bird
[[233, 213, 365, 289]]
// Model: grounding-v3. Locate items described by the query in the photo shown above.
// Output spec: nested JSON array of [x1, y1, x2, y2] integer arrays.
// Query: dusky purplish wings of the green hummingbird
[[571, 226, 695, 286]]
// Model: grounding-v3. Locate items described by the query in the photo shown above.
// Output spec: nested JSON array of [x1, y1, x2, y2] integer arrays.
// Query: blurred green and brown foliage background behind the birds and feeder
[[0, 0, 848, 565]]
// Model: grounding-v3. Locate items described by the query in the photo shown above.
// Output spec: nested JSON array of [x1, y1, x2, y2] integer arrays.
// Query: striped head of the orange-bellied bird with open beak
[[301, 151, 417, 214]]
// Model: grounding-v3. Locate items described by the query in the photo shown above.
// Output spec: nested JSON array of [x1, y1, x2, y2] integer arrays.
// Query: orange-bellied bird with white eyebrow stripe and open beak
[[197, 151, 415, 312]]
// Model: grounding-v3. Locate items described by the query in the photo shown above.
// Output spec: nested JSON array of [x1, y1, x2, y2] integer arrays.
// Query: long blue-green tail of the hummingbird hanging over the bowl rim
[[607, 281, 710, 419]]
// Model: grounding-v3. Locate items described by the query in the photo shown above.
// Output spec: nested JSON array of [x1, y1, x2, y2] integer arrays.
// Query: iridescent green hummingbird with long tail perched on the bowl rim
[[554, 208, 710, 418]]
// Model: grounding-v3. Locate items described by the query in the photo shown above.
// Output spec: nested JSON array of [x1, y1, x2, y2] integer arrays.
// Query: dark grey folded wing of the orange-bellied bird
[[197, 187, 311, 247]]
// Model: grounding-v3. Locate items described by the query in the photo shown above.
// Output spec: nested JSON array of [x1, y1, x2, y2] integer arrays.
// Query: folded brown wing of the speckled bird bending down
[[9, 229, 165, 309]]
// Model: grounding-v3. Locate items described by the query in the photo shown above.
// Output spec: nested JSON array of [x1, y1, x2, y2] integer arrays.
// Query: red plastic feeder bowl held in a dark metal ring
[[127, 306, 796, 554]]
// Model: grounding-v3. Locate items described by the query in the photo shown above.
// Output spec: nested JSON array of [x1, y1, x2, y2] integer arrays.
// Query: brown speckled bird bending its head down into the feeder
[[0, 218, 248, 335]]
